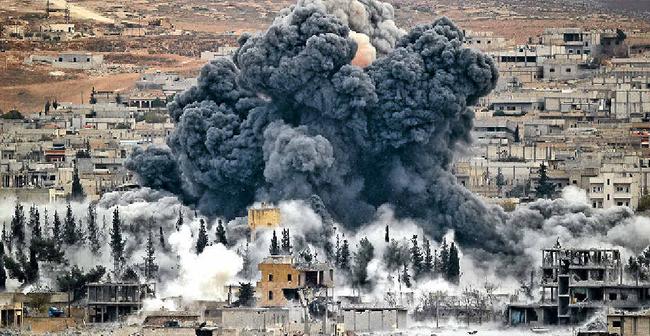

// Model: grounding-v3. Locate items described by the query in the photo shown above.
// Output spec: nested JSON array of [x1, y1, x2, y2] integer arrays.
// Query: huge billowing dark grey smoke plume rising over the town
[[128, 0, 506, 258]]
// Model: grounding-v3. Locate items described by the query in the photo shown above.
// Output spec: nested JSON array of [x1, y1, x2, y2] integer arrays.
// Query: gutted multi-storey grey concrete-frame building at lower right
[[508, 247, 650, 325]]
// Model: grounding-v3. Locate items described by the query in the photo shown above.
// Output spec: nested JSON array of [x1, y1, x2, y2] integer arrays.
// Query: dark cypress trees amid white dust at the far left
[[0, 203, 166, 290]]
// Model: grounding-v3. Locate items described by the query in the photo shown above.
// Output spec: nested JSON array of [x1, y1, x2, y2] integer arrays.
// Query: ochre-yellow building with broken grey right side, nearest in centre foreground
[[257, 255, 334, 307]]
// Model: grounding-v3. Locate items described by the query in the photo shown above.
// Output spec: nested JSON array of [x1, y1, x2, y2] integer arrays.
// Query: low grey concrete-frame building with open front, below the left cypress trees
[[86, 283, 156, 323]]
